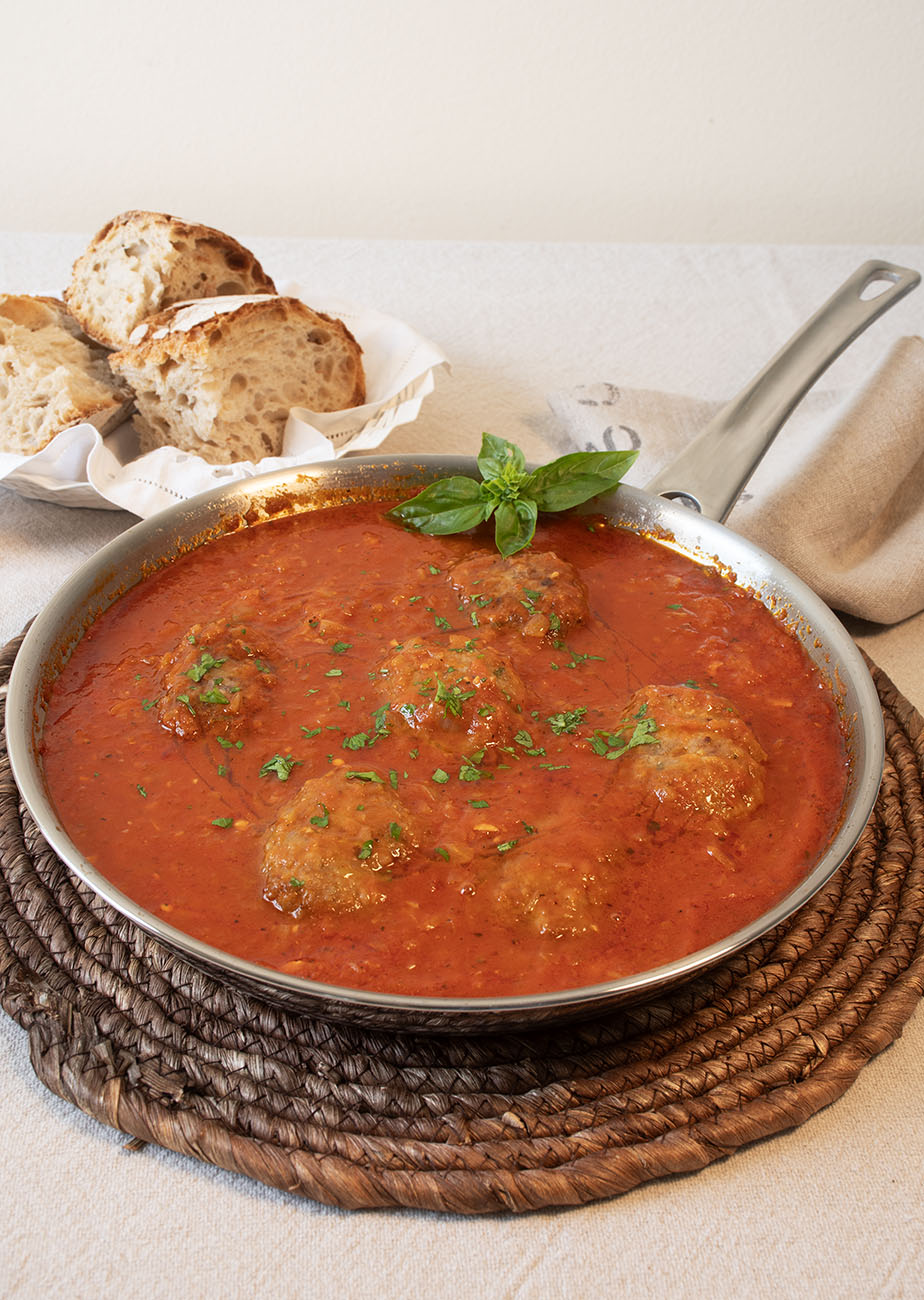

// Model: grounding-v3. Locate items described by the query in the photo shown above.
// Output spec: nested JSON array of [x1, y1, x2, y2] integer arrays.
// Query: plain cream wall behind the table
[[0, 0, 924, 243]]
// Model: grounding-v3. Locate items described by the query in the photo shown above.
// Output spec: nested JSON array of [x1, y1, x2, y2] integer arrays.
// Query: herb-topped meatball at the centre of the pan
[[371, 637, 526, 750]]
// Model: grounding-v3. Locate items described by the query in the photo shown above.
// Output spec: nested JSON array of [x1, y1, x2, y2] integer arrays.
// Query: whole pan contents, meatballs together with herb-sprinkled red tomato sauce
[[44, 485, 843, 996]]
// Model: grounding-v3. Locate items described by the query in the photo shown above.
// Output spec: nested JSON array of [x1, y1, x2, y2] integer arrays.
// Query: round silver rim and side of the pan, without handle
[[6, 455, 885, 1031]]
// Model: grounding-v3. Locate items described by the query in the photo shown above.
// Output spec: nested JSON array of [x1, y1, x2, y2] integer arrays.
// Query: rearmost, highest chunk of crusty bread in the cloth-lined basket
[[64, 212, 276, 347]]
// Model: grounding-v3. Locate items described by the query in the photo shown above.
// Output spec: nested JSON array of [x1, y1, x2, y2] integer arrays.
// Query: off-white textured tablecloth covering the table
[[0, 231, 924, 1300]]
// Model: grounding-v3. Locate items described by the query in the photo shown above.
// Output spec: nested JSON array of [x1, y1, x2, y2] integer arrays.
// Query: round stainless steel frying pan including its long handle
[[6, 261, 920, 1032]]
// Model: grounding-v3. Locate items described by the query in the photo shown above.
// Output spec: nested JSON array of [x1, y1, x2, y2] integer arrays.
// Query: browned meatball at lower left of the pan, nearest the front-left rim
[[263, 768, 418, 917]]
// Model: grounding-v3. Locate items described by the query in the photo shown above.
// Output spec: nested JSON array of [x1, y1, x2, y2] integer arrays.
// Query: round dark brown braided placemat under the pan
[[0, 629, 924, 1213]]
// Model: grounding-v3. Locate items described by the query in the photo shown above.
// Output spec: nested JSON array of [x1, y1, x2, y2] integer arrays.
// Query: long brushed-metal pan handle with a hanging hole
[[646, 261, 921, 520]]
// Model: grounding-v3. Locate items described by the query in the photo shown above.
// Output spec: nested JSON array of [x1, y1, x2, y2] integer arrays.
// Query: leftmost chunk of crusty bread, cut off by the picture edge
[[0, 294, 131, 456]]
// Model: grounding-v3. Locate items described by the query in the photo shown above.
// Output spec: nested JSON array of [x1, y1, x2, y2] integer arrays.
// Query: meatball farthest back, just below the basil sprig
[[450, 550, 587, 637]]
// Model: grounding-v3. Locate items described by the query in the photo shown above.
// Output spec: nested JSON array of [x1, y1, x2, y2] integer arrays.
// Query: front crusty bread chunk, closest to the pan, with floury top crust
[[112, 296, 365, 464]]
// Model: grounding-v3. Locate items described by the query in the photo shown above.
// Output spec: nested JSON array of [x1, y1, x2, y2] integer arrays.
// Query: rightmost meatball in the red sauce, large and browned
[[613, 686, 767, 822]]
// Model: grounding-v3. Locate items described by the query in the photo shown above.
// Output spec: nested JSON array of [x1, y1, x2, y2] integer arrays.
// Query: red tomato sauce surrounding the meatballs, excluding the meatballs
[[43, 504, 846, 996]]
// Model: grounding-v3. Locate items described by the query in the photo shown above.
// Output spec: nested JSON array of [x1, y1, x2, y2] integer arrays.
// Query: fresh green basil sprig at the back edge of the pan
[[387, 433, 638, 555]]
